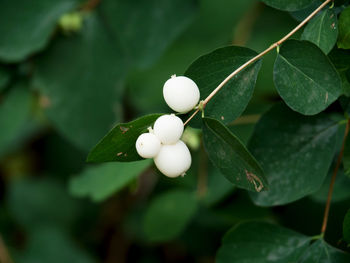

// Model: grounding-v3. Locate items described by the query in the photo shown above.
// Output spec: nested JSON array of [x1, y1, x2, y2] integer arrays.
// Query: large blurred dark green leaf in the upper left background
[[34, 14, 126, 151]]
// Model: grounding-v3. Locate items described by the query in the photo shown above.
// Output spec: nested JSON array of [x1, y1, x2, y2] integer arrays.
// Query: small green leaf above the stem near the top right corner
[[301, 9, 338, 54]]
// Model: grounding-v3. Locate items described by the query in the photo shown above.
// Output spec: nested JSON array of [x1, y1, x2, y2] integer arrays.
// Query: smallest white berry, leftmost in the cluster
[[136, 133, 161, 158]]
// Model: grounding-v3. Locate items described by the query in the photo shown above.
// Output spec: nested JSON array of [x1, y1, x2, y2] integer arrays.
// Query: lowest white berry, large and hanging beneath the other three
[[154, 141, 192, 177]]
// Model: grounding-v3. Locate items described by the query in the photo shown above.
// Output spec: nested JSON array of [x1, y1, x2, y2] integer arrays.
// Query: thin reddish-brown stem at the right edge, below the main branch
[[321, 119, 350, 236]]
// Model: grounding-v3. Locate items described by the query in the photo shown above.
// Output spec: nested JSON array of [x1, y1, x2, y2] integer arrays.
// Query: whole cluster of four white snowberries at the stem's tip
[[136, 75, 200, 177]]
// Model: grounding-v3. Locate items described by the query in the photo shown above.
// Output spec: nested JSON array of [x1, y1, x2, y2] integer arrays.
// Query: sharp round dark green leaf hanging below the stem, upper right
[[273, 40, 342, 115]]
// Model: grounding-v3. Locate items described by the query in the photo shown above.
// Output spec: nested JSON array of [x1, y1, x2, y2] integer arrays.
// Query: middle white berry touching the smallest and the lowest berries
[[153, 114, 184, 144]]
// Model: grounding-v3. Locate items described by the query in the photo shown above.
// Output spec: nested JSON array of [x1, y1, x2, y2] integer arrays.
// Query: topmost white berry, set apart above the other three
[[163, 75, 200, 113]]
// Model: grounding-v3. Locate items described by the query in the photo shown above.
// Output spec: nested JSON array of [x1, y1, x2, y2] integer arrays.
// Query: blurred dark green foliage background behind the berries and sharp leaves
[[0, 0, 350, 263]]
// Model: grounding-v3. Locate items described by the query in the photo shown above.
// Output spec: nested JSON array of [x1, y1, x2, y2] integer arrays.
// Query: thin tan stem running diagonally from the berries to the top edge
[[184, 0, 333, 125]]
